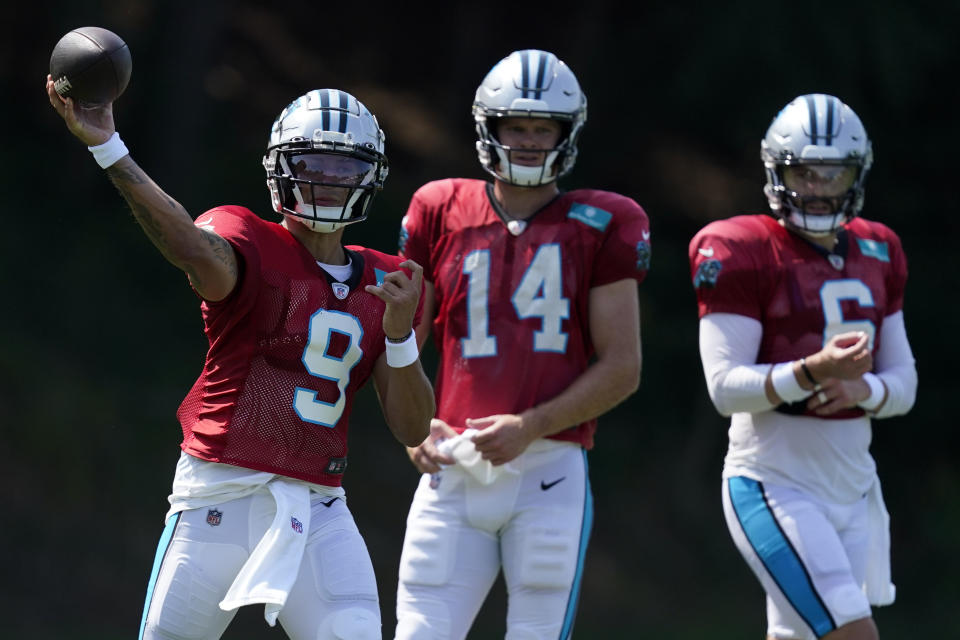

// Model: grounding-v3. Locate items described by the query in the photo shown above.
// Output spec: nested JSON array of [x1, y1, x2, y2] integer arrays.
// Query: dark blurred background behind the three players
[[0, 0, 960, 640]]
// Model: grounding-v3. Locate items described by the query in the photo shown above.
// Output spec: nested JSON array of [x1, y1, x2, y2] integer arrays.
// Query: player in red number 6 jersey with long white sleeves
[[690, 94, 917, 640]]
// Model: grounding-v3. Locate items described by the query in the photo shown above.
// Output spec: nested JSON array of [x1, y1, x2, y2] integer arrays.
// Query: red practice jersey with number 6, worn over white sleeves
[[690, 215, 907, 419]]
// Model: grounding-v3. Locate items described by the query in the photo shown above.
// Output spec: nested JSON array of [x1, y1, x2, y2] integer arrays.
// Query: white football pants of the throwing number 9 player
[[138, 489, 380, 640]]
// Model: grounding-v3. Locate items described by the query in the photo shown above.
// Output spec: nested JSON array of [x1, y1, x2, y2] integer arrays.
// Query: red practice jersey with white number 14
[[400, 179, 650, 449]]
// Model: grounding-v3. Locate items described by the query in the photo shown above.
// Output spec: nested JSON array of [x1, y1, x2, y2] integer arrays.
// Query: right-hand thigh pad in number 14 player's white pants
[[517, 528, 580, 589]]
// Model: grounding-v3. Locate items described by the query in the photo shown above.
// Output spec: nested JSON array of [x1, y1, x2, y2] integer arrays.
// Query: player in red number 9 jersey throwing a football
[[47, 77, 435, 640]]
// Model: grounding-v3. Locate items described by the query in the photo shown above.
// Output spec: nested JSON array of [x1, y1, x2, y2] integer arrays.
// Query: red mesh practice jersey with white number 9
[[177, 206, 419, 486]]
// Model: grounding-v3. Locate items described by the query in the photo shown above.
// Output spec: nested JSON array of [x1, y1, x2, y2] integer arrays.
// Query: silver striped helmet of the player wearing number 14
[[473, 49, 587, 187]]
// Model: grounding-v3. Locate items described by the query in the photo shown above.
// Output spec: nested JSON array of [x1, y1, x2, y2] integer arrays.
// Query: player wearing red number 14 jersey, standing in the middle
[[396, 50, 650, 639]]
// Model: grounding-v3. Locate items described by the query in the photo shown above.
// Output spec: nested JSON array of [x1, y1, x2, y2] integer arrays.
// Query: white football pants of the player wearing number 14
[[396, 440, 593, 640]]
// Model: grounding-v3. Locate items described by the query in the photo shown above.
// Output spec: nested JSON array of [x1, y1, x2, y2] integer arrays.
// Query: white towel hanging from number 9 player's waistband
[[220, 478, 310, 627]]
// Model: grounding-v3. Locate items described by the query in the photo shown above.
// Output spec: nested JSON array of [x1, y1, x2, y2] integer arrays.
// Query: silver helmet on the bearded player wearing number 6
[[760, 93, 873, 236]]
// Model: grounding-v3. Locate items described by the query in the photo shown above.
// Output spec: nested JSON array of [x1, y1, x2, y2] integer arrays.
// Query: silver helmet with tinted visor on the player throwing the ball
[[263, 89, 388, 233]]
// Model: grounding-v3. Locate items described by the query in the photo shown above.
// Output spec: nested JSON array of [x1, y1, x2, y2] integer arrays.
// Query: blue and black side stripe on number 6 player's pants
[[727, 476, 837, 638]]
